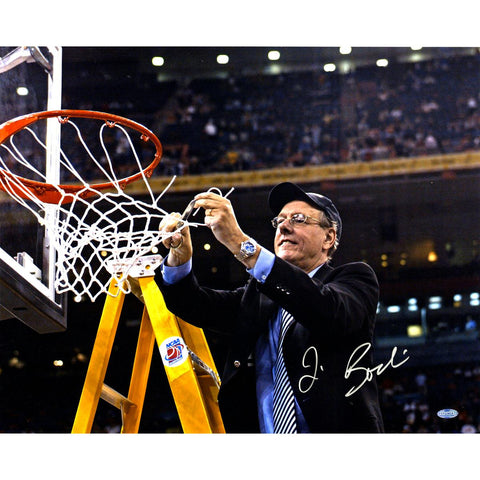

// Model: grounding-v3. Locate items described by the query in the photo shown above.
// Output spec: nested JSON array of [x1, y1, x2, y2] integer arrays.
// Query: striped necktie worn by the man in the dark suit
[[273, 310, 297, 433]]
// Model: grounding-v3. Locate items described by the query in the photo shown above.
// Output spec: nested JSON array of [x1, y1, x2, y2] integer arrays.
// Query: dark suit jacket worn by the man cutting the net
[[159, 257, 383, 433]]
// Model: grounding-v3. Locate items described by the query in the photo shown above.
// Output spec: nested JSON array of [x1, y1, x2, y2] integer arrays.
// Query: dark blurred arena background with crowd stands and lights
[[0, 47, 480, 434]]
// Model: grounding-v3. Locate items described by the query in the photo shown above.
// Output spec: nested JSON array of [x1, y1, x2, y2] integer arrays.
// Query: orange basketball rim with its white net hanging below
[[0, 110, 201, 301]]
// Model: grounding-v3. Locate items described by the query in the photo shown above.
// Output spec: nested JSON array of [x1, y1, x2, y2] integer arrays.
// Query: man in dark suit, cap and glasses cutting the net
[[159, 182, 383, 433]]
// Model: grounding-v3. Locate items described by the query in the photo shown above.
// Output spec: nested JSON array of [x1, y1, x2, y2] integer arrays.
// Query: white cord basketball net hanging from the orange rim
[[0, 112, 221, 301]]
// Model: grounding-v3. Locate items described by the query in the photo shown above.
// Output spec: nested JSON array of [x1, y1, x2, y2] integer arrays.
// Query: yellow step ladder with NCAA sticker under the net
[[72, 255, 225, 433]]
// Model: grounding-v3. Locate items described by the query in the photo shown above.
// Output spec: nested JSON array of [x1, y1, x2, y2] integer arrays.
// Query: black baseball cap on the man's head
[[268, 182, 342, 240]]
